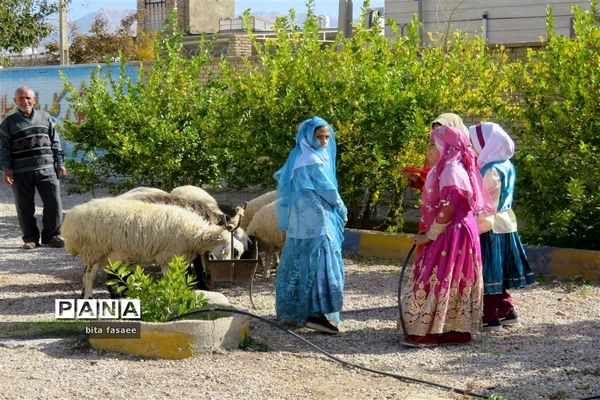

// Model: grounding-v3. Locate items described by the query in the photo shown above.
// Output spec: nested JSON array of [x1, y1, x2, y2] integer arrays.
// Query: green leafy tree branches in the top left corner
[[0, 0, 62, 53]]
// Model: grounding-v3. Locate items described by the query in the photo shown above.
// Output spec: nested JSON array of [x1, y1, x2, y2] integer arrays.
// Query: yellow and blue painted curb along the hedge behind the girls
[[342, 229, 600, 283]]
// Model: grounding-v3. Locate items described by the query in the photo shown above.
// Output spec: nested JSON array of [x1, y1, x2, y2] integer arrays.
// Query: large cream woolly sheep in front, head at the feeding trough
[[62, 198, 231, 298]]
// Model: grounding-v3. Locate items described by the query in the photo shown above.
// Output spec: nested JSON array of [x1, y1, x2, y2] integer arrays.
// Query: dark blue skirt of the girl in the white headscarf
[[480, 231, 535, 294]]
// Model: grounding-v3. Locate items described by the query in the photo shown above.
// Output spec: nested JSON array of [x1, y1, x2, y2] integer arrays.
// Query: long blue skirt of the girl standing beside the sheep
[[275, 235, 345, 325]]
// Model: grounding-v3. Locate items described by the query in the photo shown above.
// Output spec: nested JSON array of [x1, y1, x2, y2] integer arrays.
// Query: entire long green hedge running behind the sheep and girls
[[65, 1, 600, 248]]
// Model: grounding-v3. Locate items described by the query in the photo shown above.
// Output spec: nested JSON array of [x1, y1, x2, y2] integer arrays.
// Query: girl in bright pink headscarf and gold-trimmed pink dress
[[400, 126, 493, 347]]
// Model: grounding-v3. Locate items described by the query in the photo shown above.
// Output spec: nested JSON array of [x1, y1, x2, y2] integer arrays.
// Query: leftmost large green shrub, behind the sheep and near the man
[[64, 15, 221, 191]]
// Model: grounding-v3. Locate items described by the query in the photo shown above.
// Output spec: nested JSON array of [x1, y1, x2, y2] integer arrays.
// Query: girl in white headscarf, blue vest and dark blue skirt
[[469, 122, 535, 331]]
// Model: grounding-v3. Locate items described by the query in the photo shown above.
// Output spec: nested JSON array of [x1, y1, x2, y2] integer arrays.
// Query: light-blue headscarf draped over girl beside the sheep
[[273, 117, 338, 230]]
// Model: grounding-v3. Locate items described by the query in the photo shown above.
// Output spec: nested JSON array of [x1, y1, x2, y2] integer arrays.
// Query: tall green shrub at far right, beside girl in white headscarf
[[506, 0, 600, 250]]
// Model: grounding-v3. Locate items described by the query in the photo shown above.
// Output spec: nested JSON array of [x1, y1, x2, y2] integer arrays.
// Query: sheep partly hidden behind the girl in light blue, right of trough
[[246, 201, 285, 278]]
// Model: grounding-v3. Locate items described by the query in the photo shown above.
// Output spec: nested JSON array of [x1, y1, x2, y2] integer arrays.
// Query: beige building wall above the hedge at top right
[[385, 0, 590, 45]]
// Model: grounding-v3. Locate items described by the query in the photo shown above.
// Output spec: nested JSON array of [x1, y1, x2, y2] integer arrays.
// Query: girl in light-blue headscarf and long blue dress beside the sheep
[[274, 117, 347, 333]]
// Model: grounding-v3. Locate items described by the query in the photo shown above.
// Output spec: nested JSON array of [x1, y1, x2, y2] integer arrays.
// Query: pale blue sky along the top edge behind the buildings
[[68, 0, 384, 21]]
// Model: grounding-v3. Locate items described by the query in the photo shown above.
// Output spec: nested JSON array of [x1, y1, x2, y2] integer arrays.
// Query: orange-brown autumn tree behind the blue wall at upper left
[[46, 14, 155, 64]]
